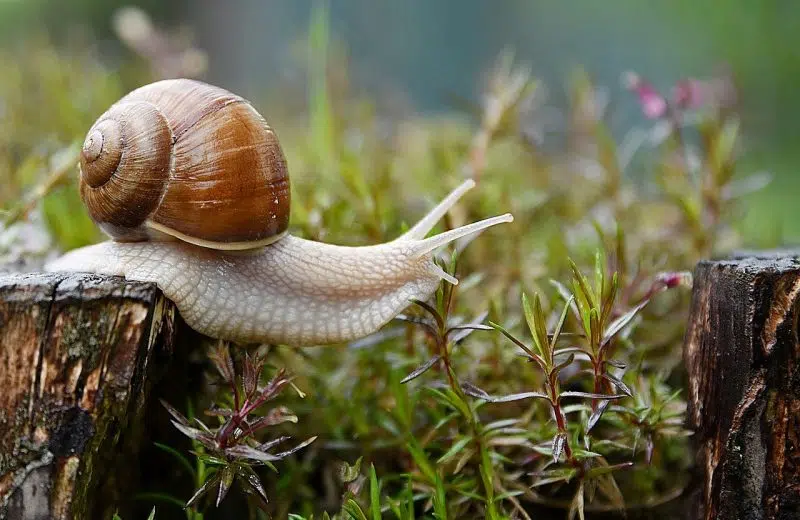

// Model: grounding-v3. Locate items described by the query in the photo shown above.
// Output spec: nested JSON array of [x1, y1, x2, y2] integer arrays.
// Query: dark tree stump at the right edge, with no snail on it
[[684, 251, 800, 520]]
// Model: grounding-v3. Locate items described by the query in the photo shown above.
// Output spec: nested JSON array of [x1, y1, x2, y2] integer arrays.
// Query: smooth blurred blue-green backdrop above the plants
[[0, 0, 800, 240]]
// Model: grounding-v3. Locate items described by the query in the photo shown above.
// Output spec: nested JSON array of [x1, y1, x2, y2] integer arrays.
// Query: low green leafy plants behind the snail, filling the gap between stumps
[[0, 11, 765, 520]]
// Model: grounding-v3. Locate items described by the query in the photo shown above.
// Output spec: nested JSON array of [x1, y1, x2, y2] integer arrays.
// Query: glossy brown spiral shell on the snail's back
[[80, 79, 290, 250]]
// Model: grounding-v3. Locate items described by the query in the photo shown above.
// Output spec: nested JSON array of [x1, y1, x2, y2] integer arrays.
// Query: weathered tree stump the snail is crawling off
[[0, 274, 176, 519]]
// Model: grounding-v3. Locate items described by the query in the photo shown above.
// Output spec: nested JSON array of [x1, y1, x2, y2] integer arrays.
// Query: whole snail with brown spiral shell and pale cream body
[[46, 79, 513, 346]]
